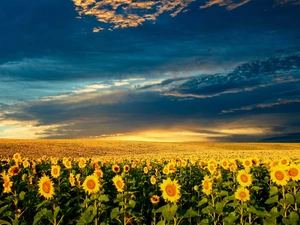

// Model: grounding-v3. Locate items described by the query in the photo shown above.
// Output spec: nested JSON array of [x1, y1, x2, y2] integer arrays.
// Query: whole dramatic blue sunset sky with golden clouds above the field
[[0, 0, 300, 142]]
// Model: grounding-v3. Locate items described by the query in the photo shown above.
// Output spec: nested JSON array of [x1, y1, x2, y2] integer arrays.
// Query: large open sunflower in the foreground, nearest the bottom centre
[[159, 178, 181, 203]]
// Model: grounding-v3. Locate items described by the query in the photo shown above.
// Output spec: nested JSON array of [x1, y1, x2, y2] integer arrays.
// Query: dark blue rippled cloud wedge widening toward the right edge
[[161, 55, 300, 98]]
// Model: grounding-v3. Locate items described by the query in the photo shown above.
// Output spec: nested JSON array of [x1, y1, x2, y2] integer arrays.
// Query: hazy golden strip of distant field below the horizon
[[0, 139, 300, 159]]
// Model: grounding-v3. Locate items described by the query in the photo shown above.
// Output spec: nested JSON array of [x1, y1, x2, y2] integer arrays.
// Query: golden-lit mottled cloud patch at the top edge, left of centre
[[73, 0, 195, 32]]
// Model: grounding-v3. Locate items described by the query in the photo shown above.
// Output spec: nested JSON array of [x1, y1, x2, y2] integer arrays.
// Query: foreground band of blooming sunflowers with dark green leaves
[[0, 153, 300, 225]]
